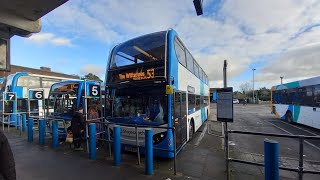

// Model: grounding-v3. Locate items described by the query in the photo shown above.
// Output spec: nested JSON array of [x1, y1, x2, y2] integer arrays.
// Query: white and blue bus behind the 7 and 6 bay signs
[[1, 72, 77, 125]]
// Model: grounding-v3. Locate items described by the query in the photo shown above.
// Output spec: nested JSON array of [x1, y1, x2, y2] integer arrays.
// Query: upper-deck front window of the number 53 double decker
[[111, 31, 166, 68]]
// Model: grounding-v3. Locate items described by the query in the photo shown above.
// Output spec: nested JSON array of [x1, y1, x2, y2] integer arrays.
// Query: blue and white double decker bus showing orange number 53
[[105, 29, 210, 158]]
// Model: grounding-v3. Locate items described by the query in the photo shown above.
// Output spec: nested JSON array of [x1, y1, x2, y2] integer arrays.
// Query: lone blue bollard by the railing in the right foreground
[[264, 139, 279, 180]]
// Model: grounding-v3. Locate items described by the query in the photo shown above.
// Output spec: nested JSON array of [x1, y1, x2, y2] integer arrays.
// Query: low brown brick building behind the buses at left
[[0, 65, 80, 79]]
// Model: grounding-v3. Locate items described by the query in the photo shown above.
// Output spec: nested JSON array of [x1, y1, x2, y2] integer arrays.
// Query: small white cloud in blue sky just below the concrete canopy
[[28, 33, 72, 46]]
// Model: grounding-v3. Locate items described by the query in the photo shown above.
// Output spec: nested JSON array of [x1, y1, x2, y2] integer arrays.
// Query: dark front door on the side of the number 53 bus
[[174, 92, 187, 148]]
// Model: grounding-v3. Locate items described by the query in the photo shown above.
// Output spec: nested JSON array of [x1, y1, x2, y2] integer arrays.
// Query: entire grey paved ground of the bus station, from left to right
[[6, 105, 320, 180]]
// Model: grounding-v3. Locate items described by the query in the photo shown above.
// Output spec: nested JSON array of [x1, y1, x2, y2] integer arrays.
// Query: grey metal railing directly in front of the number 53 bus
[[86, 118, 177, 175]]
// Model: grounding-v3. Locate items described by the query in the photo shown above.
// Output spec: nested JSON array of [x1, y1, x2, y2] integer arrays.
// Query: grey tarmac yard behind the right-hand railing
[[210, 105, 320, 179]]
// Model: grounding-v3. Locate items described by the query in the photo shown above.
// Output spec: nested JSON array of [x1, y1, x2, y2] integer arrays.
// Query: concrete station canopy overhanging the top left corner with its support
[[0, 0, 68, 71]]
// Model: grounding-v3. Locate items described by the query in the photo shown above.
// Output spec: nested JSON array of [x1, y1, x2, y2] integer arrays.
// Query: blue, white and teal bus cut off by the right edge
[[271, 76, 320, 129]]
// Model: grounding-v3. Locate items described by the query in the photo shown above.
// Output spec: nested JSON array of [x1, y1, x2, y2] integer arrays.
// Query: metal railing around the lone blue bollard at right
[[226, 130, 320, 180]]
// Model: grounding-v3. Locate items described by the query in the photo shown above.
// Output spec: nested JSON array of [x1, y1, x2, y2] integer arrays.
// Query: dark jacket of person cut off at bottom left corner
[[0, 130, 16, 180]]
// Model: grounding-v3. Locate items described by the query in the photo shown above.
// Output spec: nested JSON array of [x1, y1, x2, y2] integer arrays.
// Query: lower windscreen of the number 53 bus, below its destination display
[[113, 87, 167, 123]]
